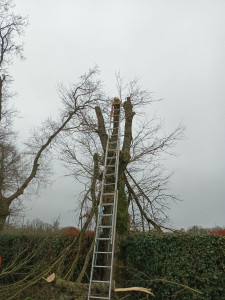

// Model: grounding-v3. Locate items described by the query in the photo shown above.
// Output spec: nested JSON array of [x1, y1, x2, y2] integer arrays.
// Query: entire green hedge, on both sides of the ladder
[[0, 234, 225, 300]]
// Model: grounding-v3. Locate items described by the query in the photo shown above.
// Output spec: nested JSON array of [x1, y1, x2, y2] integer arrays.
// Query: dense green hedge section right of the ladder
[[121, 234, 225, 300]]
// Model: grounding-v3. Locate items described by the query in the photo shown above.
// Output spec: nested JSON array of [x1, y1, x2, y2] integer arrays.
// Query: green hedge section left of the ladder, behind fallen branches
[[0, 234, 93, 284]]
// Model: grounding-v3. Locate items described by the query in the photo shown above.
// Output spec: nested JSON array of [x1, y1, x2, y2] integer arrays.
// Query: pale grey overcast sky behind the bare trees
[[11, 0, 225, 228]]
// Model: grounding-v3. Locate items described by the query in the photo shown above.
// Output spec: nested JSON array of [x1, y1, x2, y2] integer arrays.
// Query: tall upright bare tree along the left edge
[[0, 0, 27, 231]]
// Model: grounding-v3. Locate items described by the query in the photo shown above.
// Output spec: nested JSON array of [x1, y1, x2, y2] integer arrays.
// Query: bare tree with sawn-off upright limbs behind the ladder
[[59, 76, 184, 235]]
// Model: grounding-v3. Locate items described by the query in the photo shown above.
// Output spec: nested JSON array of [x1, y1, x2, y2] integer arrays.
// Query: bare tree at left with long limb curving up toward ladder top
[[0, 55, 101, 232]]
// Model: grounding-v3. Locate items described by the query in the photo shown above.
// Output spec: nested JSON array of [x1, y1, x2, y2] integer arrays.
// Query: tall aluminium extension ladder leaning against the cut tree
[[88, 101, 121, 300]]
